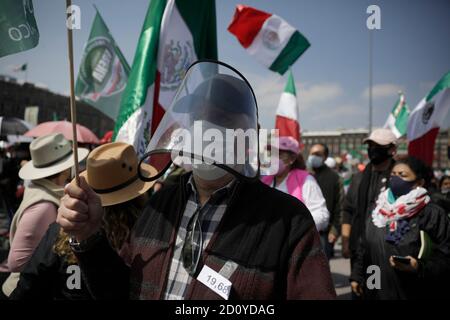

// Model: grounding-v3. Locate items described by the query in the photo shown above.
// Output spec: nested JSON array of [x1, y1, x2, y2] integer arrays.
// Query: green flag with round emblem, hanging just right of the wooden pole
[[75, 11, 130, 120]]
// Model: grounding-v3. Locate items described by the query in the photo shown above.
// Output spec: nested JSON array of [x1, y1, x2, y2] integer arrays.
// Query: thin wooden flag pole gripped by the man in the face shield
[[66, 0, 80, 186]]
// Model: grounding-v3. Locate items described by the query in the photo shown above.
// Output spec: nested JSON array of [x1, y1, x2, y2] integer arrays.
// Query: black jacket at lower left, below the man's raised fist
[[9, 223, 92, 300]]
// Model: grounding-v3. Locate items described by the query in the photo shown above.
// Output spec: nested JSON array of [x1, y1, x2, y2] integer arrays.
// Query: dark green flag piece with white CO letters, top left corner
[[0, 0, 39, 58]]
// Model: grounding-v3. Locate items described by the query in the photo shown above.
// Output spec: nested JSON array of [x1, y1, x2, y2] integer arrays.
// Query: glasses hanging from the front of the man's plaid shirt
[[182, 210, 203, 276]]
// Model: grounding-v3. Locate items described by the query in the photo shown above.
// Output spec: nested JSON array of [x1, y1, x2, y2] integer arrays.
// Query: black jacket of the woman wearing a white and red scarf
[[350, 203, 450, 300]]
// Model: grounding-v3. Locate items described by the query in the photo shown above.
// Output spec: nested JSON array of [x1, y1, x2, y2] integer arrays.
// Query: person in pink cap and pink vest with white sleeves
[[262, 137, 330, 231]]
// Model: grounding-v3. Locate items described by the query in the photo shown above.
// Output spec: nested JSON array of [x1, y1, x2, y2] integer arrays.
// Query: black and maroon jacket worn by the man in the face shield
[[73, 174, 335, 300]]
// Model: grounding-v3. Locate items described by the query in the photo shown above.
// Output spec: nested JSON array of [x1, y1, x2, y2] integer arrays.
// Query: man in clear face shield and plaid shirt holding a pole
[[58, 61, 335, 300]]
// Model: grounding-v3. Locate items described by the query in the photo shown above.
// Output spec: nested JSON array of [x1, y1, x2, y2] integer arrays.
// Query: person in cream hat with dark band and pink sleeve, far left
[[2, 134, 89, 296]]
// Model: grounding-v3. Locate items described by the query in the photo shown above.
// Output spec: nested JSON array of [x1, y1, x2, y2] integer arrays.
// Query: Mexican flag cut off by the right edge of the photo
[[407, 72, 450, 166]]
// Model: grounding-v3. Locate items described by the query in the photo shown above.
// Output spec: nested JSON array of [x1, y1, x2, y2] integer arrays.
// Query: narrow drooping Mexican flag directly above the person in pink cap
[[275, 70, 301, 145]]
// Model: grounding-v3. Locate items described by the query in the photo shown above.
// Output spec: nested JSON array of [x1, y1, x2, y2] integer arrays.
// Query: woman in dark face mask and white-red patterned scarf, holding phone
[[350, 157, 450, 299]]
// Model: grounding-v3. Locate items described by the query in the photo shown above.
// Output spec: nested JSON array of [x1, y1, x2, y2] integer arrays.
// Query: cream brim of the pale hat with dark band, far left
[[19, 148, 89, 180]]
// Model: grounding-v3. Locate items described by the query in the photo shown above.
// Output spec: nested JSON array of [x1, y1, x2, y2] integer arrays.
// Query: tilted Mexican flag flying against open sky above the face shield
[[228, 5, 310, 74]]
